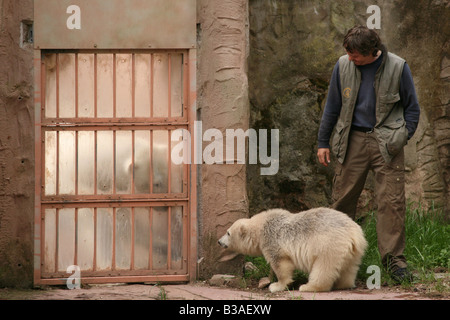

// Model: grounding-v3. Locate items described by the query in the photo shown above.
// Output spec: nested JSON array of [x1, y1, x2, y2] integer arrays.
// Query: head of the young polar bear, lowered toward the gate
[[218, 219, 261, 255]]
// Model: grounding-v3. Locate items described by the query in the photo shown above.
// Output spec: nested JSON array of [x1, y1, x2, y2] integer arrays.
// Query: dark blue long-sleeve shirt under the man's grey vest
[[318, 53, 420, 148]]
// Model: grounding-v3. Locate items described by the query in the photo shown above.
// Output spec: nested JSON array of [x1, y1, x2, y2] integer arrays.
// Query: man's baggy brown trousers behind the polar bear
[[332, 130, 407, 271]]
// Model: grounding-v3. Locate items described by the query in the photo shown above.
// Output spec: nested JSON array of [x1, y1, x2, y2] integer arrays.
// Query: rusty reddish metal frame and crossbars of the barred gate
[[34, 48, 197, 285]]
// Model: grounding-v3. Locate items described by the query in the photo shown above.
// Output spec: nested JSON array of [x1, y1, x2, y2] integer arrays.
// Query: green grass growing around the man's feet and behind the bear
[[245, 205, 450, 292]]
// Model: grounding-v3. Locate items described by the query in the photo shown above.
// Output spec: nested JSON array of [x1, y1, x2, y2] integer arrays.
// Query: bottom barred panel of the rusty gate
[[42, 203, 188, 279]]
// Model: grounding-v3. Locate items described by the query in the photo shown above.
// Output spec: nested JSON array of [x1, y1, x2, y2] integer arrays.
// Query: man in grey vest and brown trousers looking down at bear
[[317, 26, 420, 282]]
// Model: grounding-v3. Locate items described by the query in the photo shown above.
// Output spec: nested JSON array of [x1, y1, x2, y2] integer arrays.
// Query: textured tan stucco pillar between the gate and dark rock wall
[[197, 0, 249, 277]]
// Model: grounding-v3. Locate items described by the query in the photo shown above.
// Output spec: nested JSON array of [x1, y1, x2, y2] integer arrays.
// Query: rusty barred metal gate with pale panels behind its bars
[[35, 50, 195, 284]]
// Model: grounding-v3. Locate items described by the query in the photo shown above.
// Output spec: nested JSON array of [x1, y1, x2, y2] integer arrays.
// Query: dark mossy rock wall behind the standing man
[[248, 0, 450, 218]]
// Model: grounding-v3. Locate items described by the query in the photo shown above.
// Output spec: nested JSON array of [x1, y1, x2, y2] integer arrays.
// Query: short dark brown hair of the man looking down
[[343, 26, 383, 57]]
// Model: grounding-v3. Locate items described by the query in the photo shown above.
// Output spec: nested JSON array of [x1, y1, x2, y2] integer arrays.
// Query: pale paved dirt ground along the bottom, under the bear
[[0, 274, 450, 300]]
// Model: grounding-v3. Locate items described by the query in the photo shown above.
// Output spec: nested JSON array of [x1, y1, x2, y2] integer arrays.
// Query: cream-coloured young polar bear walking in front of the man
[[219, 208, 367, 292]]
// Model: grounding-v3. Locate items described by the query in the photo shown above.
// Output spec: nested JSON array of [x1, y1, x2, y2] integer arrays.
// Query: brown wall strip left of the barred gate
[[0, 0, 34, 287]]
